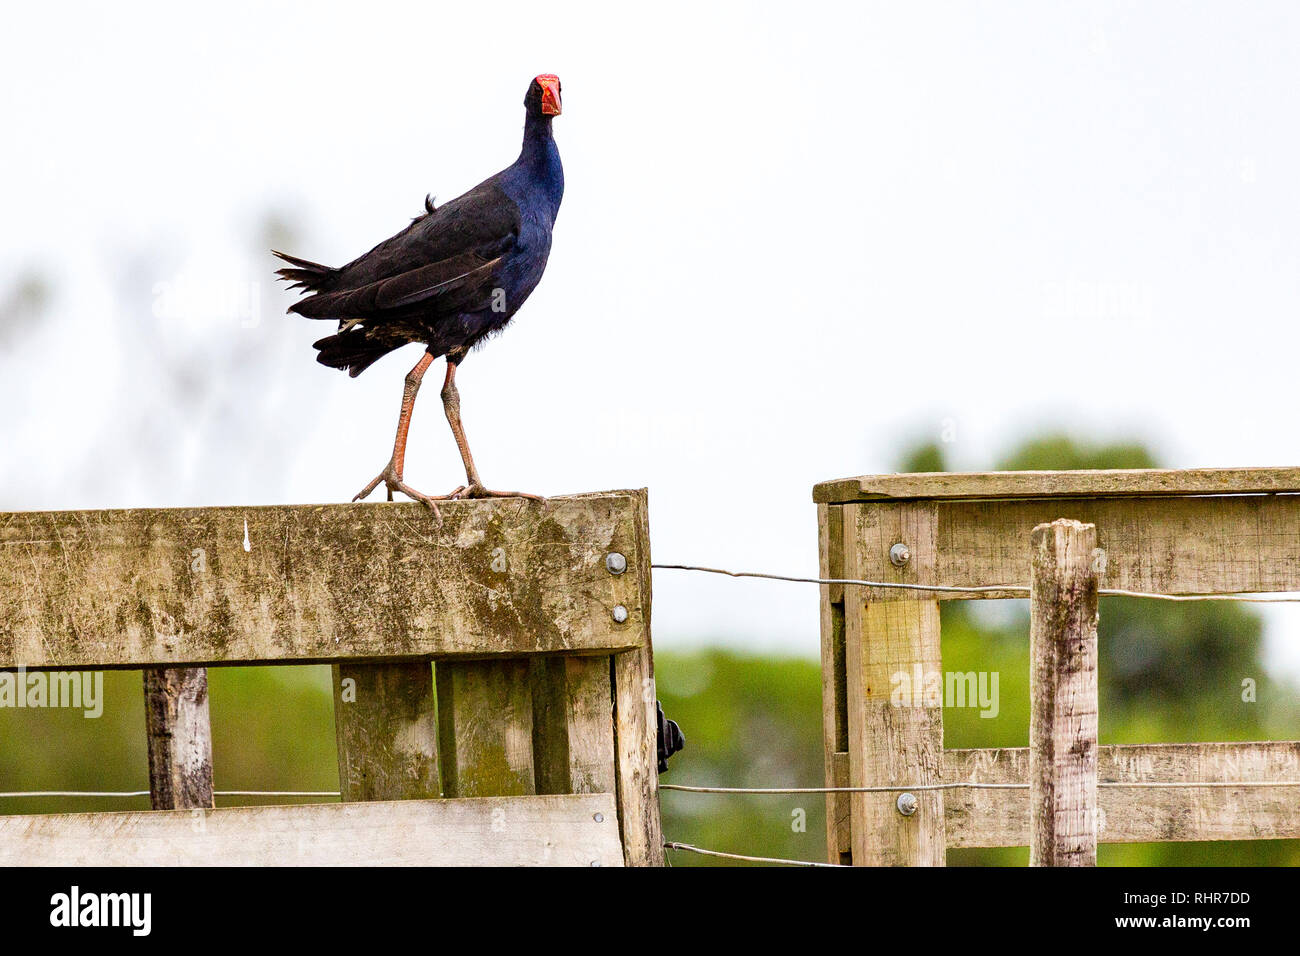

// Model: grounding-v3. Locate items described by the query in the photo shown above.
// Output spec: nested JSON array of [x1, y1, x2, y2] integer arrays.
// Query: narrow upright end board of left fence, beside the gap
[[614, 492, 664, 866]]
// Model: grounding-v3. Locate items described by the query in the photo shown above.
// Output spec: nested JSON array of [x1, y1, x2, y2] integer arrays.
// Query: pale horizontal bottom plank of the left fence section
[[0, 793, 623, 866]]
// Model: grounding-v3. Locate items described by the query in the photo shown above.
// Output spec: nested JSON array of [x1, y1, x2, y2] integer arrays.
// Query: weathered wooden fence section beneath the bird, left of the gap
[[0, 492, 663, 865]]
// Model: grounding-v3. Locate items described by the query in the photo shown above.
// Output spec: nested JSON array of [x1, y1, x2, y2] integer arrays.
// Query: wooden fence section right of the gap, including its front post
[[814, 468, 1300, 865]]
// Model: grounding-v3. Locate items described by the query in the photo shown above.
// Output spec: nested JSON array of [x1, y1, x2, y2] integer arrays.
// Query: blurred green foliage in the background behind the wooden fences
[[0, 436, 1300, 866]]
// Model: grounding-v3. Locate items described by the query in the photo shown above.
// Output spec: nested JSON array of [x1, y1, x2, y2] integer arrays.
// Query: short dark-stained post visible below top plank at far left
[[144, 667, 216, 810]]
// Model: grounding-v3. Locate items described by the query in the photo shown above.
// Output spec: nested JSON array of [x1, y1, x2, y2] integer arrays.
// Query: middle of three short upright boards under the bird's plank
[[436, 659, 537, 797]]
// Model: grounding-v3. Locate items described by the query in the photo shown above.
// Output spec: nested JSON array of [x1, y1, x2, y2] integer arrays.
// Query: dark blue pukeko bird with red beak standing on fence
[[276, 73, 564, 514]]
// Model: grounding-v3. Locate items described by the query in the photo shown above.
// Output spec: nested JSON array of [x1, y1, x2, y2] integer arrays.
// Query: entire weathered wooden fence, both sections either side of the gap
[[0, 468, 1300, 865]]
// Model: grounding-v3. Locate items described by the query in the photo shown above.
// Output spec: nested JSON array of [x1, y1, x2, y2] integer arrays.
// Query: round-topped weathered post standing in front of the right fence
[[1030, 518, 1100, 866]]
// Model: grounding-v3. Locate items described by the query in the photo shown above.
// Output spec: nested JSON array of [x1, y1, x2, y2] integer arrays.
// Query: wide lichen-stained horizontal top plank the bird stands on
[[0, 492, 646, 667]]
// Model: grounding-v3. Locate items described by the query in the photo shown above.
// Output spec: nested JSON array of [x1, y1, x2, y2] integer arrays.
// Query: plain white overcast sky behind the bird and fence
[[0, 0, 1300, 672]]
